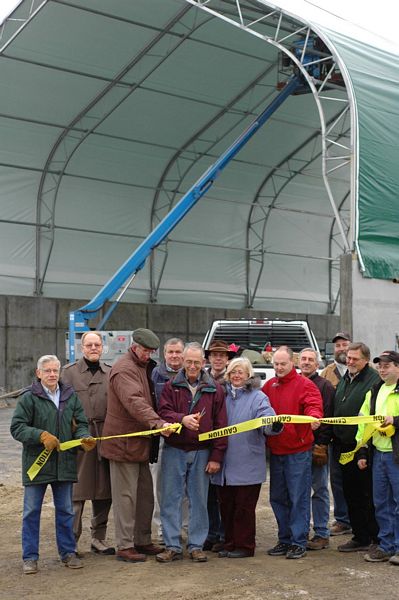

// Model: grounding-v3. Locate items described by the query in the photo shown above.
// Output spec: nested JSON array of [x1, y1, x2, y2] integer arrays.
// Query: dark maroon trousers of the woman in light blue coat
[[218, 483, 261, 556]]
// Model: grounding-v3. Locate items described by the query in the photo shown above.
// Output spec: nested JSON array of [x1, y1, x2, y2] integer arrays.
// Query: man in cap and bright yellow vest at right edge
[[356, 350, 399, 565]]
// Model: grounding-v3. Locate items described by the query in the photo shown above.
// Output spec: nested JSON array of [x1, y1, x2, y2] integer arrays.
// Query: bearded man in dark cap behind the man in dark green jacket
[[320, 331, 352, 535]]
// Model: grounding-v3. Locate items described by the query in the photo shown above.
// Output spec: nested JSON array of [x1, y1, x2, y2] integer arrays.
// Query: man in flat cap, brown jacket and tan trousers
[[101, 328, 173, 563]]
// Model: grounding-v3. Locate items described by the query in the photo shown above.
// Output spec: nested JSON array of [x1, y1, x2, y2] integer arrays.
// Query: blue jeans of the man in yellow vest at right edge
[[373, 450, 399, 554]]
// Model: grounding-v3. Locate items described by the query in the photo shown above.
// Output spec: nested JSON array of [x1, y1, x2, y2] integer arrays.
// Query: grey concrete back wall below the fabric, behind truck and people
[[0, 296, 340, 391]]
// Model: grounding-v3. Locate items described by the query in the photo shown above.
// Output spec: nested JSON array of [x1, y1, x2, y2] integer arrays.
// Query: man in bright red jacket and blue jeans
[[262, 346, 323, 558]]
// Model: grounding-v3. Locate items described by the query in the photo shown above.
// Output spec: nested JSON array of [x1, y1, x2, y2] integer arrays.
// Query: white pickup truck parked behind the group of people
[[203, 319, 320, 381]]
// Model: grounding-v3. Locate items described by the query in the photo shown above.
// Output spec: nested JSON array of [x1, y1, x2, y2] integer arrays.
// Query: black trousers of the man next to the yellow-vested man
[[341, 458, 378, 546]]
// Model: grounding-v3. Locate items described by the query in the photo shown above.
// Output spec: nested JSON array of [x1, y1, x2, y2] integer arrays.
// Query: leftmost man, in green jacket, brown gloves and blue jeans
[[10, 354, 96, 575]]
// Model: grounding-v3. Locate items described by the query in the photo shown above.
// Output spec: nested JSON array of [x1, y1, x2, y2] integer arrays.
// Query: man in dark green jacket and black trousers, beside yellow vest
[[333, 342, 380, 552]]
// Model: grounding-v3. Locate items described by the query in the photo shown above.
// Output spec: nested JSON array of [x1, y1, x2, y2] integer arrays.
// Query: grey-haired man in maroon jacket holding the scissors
[[156, 342, 227, 563]]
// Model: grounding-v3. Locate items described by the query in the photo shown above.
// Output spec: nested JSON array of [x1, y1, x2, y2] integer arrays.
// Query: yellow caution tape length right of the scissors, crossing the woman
[[198, 415, 385, 442]]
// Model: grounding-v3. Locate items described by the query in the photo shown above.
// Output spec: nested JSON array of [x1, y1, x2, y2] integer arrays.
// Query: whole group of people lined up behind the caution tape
[[11, 328, 399, 574]]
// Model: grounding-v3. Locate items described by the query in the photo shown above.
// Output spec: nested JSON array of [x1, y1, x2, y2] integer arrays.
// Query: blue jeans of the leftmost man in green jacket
[[22, 481, 76, 560]]
